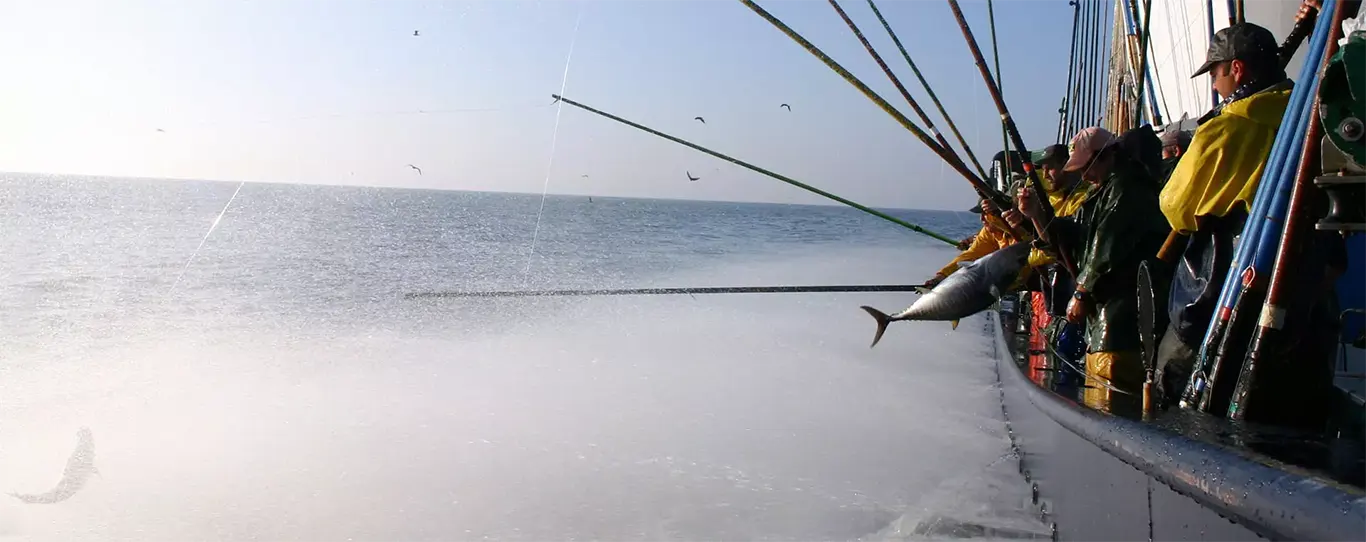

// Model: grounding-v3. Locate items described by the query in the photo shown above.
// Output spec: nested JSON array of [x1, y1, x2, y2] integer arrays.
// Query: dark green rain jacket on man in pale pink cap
[[1068, 153, 1169, 352]]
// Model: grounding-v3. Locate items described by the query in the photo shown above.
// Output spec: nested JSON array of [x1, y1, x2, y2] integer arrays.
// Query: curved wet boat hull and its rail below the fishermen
[[989, 308, 1366, 542]]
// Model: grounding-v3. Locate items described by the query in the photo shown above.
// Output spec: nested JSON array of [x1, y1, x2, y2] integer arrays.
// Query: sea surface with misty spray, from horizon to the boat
[[0, 175, 1041, 541]]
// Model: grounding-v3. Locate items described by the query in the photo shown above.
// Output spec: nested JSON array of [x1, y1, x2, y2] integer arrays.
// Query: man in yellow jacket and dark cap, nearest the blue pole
[[1157, 21, 1305, 404]]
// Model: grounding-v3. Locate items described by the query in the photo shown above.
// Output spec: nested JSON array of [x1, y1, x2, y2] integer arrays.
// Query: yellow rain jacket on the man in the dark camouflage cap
[[1160, 89, 1291, 232]]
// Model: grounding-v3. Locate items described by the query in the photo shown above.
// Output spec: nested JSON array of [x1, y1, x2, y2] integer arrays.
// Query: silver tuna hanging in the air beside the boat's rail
[[862, 243, 1030, 348]]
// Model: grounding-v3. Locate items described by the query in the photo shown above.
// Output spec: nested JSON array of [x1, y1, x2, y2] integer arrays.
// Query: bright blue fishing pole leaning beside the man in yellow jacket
[[1182, 0, 1337, 411]]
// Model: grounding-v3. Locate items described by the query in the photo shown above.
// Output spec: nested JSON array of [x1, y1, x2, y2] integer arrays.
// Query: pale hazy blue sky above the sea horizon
[[0, 0, 1071, 209]]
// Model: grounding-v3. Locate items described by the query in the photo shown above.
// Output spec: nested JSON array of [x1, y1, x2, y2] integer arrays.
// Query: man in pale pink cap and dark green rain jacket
[[1022, 127, 1168, 392]]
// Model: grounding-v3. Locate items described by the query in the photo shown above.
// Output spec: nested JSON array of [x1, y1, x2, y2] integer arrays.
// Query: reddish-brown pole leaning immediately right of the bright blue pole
[[1228, 0, 1355, 419]]
